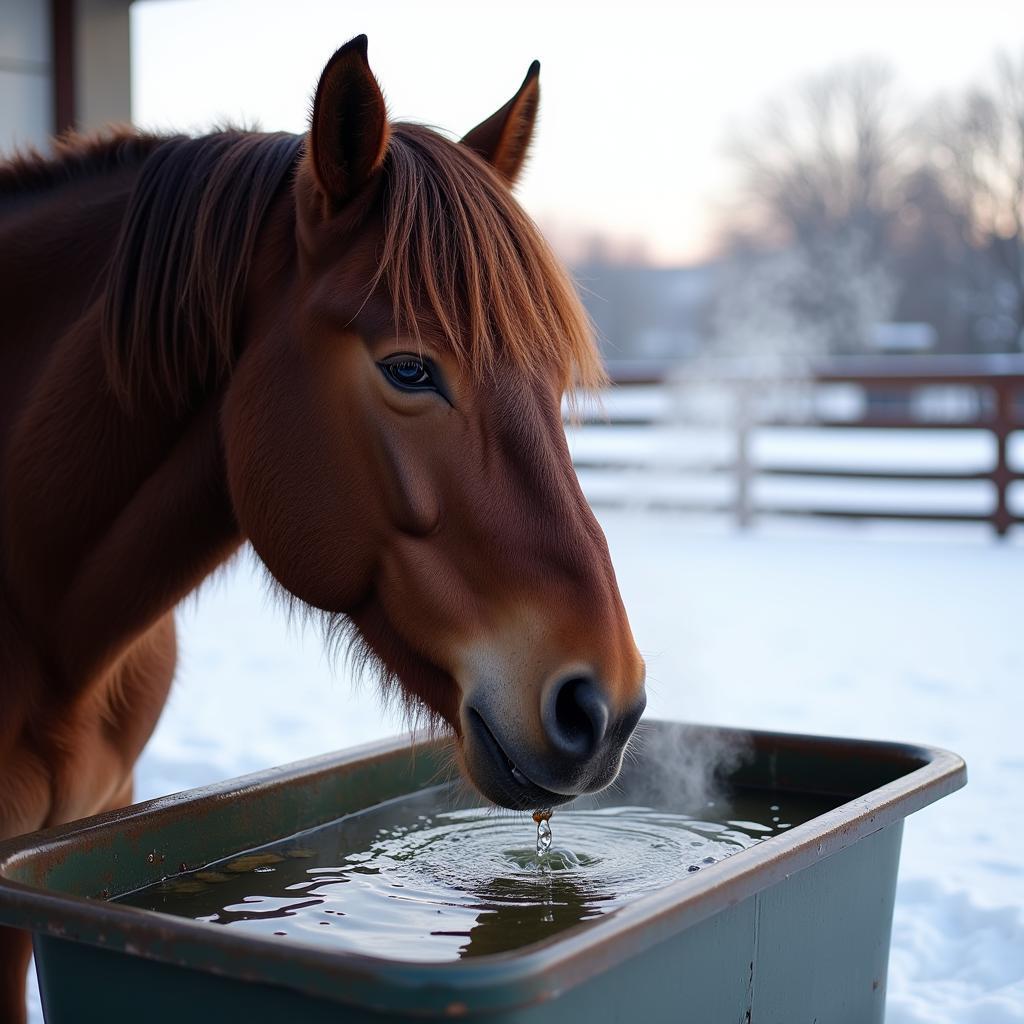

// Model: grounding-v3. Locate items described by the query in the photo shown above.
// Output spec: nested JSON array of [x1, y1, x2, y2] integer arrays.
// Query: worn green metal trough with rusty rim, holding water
[[0, 722, 966, 1024]]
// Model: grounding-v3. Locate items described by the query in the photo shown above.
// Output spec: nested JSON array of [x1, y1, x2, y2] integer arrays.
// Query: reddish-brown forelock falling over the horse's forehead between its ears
[[374, 124, 605, 397]]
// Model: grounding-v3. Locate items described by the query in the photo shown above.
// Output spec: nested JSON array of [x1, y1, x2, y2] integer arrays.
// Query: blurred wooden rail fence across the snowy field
[[574, 355, 1024, 536]]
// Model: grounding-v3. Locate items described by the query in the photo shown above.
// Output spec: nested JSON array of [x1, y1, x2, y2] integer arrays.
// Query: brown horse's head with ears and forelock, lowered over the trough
[[225, 37, 644, 808]]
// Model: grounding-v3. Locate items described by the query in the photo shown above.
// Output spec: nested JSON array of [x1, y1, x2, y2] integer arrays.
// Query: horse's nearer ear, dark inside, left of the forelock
[[309, 36, 388, 207]]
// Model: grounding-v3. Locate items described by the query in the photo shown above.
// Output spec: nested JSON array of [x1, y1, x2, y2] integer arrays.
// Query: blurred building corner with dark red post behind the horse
[[0, 0, 131, 153]]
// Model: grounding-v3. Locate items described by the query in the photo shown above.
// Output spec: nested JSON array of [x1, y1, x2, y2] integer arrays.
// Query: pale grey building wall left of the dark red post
[[0, 0, 53, 154]]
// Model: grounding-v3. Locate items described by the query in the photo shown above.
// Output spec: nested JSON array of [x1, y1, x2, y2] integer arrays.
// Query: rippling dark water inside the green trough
[[119, 786, 838, 962]]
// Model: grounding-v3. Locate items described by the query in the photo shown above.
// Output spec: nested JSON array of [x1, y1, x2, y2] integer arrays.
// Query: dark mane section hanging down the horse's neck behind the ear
[[101, 130, 303, 404]]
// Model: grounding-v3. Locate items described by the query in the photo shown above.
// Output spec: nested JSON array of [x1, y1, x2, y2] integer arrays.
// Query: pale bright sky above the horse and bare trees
[[132, 0, 1024, 263]]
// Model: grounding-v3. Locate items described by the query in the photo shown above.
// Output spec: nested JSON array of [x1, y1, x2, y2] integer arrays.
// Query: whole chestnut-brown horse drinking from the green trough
[[0, 36, 645, 1021]]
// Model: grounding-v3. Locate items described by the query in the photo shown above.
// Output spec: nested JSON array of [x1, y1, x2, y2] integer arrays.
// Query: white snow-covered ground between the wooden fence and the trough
[[25, 511, 1024, 1024]]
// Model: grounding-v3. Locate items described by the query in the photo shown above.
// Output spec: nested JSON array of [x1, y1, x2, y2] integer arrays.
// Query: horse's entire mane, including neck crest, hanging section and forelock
[[25, 124, 603, 404]]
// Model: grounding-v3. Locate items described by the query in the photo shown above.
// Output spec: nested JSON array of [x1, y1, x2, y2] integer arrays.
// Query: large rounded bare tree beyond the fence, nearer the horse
[[718, 60, 906, 351]]
